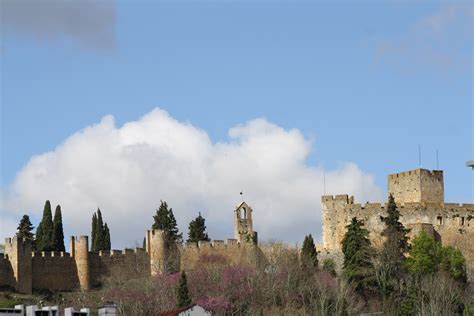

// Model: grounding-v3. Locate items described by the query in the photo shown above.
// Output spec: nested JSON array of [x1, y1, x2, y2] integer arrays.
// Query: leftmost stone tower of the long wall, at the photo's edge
[[5, 236, 32, 294]]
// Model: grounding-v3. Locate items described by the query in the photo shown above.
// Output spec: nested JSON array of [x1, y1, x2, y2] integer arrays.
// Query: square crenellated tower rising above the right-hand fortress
[[388, 168, 444, 204]]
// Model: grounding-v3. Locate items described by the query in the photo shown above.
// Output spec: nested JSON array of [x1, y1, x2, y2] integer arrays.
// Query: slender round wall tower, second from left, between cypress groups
[[70, 236, 91, 291]]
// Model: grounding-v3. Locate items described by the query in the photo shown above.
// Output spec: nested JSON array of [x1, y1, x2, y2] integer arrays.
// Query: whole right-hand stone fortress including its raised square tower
[[322, 168, 474, 277]]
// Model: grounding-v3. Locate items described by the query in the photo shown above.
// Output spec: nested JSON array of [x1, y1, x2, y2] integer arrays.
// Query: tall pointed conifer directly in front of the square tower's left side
[[376, 194, 410, 297]]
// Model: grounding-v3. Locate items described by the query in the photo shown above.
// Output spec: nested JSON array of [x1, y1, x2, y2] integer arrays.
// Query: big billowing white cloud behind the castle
[[1, 109, 382, 247]]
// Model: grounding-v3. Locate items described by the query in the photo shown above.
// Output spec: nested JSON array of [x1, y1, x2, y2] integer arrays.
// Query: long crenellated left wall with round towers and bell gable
[[0, 202, 260, 293]]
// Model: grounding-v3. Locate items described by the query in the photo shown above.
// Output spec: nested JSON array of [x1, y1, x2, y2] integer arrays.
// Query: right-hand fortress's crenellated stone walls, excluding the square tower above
[[322, 195, 474, 276]]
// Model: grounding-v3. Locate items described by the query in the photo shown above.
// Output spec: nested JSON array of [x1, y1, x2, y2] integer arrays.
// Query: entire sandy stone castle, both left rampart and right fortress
[[0, 168, 474, 293]]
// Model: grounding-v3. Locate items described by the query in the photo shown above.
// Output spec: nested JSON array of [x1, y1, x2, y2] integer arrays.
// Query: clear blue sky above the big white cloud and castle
[[0, 1, 474, 247]]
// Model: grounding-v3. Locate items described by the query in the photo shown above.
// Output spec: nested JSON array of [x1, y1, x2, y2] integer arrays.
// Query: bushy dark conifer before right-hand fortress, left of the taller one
[[341, 217, 375, 296]]
